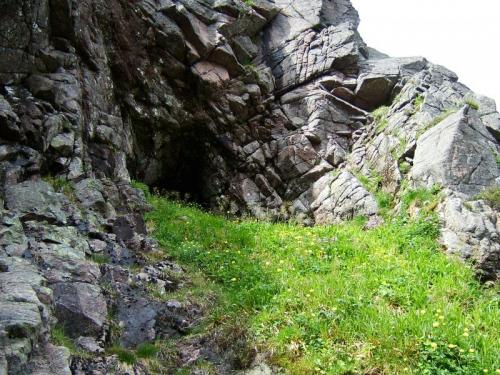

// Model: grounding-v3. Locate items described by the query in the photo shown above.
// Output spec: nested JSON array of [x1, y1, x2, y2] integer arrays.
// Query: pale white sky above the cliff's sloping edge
[[351, 0, 500, 109]]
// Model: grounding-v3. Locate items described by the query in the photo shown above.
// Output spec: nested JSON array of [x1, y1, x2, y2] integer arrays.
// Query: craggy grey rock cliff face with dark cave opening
[[0, 0, 500, 374]]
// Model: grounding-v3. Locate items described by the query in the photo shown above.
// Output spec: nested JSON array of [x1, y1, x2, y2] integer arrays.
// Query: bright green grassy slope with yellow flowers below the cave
[[142, 188, 500, 374]]
